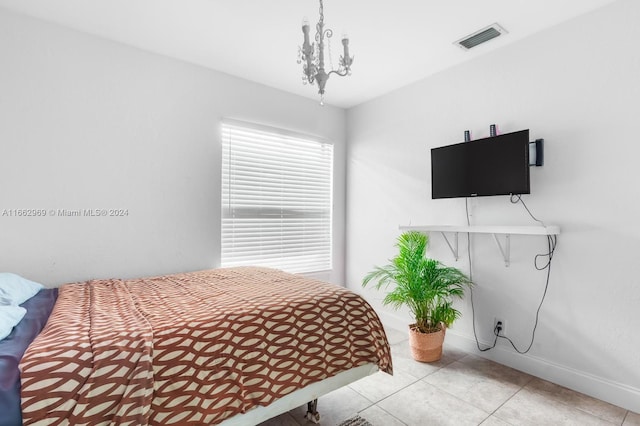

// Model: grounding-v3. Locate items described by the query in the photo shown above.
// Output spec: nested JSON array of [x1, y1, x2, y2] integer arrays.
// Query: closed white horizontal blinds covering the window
[[221, 121, 333, 273]]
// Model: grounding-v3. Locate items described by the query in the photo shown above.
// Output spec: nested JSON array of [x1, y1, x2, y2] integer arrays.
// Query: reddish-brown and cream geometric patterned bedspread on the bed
[[20, 267, 392, 425]]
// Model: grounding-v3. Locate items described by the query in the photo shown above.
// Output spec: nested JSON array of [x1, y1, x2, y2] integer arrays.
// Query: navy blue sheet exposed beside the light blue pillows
[[0, 288, 58, 426]]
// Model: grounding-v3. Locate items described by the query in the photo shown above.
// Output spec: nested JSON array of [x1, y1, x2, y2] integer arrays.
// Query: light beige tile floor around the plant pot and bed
[[260, 330, 640, 426]]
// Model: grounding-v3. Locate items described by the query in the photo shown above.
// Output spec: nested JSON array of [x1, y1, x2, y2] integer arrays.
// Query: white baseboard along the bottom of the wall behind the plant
[[379, 312, 640, 413]]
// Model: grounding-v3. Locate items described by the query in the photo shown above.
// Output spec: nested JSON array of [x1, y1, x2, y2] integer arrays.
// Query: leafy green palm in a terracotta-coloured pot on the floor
[[362, 231, 472, 362]]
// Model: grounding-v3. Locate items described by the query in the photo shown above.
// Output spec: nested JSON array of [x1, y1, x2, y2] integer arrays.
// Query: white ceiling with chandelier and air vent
[[0, 0, 615, 108]]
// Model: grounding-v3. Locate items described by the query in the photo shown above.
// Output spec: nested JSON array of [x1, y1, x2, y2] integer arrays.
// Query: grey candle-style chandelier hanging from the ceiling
[[298, 0, 353, 105]]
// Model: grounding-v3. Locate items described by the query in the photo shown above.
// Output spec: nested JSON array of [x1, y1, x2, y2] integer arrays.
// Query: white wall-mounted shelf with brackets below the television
[[400, 225, 560, 266]]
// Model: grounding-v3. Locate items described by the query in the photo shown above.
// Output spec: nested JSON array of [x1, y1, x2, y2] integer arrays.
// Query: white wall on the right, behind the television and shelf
[[347, 0, 640, 412]]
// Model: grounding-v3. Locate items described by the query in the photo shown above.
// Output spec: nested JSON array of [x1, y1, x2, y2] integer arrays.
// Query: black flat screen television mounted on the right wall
[[431, 129, 530, 199]]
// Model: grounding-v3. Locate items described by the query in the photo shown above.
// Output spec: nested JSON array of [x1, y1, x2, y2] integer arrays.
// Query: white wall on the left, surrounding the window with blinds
[[0, 9, 346, 286]]
